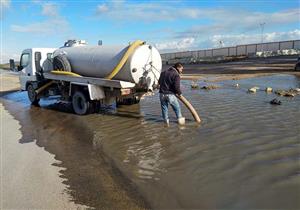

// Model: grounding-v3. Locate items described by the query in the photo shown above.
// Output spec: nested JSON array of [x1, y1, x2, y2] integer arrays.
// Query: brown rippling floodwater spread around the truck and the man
[[4, 75, 300, 209]]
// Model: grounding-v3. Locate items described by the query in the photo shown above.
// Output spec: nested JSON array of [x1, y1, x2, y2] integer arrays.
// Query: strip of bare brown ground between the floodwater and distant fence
[[178, 56, 300, 82]]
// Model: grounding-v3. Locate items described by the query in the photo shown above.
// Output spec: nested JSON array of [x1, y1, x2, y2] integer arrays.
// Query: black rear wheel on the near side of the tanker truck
[[72, 91, 91, 115]]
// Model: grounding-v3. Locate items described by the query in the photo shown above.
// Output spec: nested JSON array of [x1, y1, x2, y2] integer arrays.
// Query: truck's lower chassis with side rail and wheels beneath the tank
[[26, 73, 145, 115]]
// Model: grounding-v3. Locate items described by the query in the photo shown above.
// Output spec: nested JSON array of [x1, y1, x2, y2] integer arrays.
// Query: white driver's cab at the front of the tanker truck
[[18, 48, 56, 90]]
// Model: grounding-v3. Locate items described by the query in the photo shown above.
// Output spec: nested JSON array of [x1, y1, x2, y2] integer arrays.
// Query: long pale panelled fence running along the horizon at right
[[161, 40, 300, 61]]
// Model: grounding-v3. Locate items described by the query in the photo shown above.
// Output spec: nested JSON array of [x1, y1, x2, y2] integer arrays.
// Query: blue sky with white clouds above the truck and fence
[[0, 0, 300, 63]]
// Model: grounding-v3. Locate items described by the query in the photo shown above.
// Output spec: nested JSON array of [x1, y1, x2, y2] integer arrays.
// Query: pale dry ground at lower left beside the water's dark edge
[[0, 104, 86, 209]]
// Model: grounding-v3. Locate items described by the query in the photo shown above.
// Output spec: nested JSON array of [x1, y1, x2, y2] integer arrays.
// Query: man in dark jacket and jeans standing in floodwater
[[158, 63, 185, 125]]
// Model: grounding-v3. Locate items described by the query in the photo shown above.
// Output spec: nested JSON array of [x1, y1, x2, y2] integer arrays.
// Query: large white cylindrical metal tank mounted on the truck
[[53, 40, 162, 89]]
